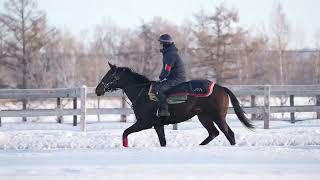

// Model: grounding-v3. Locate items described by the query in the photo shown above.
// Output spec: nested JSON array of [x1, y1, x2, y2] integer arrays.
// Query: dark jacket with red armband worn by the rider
[[159, 44, 186, 82]]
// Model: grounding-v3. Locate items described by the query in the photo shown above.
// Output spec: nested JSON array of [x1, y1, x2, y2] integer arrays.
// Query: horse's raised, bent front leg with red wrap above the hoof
[[122, 120, 152, 147]]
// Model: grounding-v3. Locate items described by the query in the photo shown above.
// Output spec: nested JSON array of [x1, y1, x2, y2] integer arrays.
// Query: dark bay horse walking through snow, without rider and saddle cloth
[[96, 63, 254, 147]]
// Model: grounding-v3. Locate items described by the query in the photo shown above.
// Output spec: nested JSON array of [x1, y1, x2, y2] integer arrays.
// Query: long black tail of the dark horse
[[223, 87, 254, 129]]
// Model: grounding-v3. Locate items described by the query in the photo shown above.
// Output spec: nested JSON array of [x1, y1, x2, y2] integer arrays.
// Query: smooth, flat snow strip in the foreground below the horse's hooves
[[0, 147, 319, 179]]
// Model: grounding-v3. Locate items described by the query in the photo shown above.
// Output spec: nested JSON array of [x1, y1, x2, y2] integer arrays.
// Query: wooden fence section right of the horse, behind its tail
[[228, 85, 320, 129]]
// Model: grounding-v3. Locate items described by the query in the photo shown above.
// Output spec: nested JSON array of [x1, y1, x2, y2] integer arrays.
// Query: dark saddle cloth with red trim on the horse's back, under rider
[[148, 80, 215, 104]]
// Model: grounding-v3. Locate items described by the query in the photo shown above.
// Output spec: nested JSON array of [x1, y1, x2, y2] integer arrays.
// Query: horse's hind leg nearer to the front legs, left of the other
[[198, 114, 219, 145]]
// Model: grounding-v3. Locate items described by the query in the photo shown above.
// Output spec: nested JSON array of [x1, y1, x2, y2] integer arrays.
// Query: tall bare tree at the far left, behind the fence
[[0, 0, 52, 88]]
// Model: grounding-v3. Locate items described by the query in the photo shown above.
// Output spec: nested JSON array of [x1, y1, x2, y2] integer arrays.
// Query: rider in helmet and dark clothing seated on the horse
[[156, 34, 186, 116]]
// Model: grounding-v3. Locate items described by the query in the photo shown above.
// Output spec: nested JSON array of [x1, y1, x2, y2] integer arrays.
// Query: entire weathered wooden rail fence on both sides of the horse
[[0, 85, 320, 131]]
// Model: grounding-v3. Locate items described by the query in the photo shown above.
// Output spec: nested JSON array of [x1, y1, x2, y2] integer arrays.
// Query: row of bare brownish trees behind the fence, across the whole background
[[0, 0, 320, 88]]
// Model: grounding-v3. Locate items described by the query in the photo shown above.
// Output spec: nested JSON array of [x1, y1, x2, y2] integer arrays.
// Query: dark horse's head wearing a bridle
[[96, 63, 126, 96]]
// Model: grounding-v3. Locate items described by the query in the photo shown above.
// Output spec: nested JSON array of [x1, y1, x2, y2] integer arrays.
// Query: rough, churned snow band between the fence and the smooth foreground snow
[[0, 120, 320, 150]]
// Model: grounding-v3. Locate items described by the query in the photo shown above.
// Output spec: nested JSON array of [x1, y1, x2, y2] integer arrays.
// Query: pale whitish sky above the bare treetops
[[0, 0, 320, 48]]
